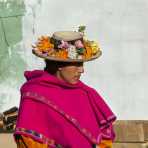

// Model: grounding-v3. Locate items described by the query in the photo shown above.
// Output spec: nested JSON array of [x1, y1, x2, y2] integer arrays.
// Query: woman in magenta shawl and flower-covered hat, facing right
[[14, 28, 116, 148]]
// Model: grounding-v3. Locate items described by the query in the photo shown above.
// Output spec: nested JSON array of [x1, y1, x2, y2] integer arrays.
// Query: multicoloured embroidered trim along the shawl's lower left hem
[[15, 127, 59, 147]]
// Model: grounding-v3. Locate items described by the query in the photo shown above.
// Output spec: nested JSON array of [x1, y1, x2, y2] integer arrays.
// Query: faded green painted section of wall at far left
[[0, 0, 26, 111]]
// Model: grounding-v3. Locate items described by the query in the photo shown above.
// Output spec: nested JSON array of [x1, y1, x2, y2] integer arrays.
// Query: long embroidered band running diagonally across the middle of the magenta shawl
[[22, 92, 99, 144]]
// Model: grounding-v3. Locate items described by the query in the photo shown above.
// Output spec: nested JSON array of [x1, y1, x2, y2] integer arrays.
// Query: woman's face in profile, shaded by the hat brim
[[57, 62, 84, 84]]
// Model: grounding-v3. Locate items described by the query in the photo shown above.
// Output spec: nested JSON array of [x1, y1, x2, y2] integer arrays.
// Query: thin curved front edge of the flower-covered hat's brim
[[32, 49, 102, 62]]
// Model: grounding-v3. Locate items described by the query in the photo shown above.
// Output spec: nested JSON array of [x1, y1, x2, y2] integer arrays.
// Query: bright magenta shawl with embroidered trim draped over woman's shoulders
[[14, 70, 116, 148]]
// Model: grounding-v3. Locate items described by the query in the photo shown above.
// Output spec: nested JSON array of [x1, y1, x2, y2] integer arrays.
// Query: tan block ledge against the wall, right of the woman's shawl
[[114, 120, 148, 143]]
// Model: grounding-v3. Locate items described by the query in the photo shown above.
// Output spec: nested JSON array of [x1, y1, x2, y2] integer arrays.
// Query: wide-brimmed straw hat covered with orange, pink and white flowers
[[32, 28, 102, 62]]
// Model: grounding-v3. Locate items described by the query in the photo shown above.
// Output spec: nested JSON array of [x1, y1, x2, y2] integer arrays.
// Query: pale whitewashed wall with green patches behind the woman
[[0, 0, 148, 119]]
